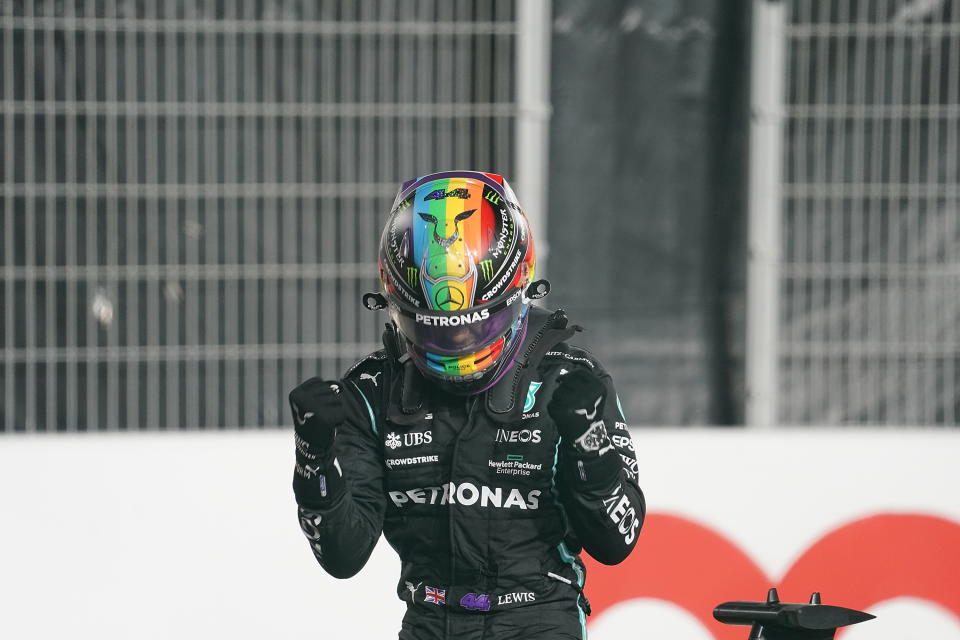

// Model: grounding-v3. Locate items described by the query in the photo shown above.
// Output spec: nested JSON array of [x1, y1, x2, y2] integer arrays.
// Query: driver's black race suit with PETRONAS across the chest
[[298, 307, 645, 640]]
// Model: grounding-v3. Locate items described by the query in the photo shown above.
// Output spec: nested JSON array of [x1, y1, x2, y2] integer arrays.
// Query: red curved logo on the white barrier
[[587, 514, 960, 640]]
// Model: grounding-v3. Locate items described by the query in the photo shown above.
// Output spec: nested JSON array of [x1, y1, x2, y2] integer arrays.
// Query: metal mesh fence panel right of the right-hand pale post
[[779, 0, 960, 425]]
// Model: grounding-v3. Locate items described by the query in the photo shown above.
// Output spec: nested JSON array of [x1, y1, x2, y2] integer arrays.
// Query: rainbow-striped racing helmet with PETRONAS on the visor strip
[[379, 171, 545, 394]]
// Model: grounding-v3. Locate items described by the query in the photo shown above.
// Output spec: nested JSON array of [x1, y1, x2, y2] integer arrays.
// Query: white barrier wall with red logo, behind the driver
[[0, 430, 960, 640]]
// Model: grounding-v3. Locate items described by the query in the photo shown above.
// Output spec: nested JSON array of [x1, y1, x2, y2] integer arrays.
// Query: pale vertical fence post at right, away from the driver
[[746, 0, 786, 428]]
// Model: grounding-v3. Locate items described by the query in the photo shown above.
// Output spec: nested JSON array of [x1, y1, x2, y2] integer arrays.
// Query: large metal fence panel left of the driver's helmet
[[0, 0, 517, 431]]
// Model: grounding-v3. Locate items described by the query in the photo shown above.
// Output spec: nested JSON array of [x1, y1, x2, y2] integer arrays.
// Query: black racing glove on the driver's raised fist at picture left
[[289, 378, 346, 507]]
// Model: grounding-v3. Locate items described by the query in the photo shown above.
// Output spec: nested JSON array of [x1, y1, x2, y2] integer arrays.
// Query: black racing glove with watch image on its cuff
[[547, 369, 613, 458]]
